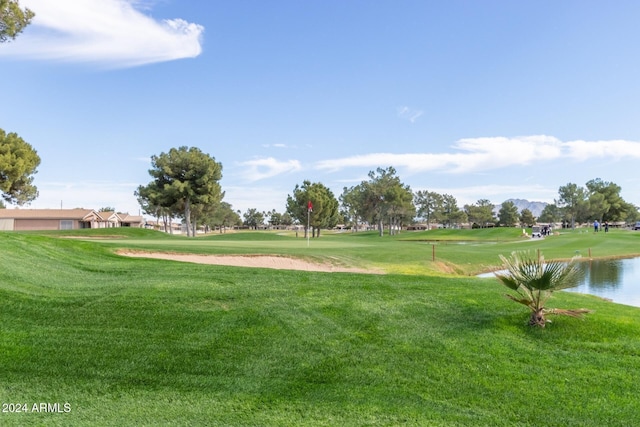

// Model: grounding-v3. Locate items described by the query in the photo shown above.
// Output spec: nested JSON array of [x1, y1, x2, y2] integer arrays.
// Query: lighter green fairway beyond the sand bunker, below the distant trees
[[69, 228, 640, 276]]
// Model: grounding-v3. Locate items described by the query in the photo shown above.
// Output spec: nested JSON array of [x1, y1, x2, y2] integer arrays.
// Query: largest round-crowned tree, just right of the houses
[[138, 147, 224, 236]]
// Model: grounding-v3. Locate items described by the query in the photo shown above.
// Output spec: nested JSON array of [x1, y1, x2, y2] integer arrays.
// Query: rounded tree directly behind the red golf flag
[[287, 180, 340, 237]]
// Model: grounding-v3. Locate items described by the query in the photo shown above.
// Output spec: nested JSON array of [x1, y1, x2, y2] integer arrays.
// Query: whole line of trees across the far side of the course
[[135, 147, 639, 238]]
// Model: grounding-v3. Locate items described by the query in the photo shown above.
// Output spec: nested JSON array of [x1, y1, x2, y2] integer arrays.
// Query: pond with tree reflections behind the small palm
[[479, 258, 640, 307]]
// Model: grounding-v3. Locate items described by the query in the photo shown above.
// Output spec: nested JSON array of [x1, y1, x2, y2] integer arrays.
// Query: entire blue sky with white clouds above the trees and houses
[[0, 0, 640, 214]]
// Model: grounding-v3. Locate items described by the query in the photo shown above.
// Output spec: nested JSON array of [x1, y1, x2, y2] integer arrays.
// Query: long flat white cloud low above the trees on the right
[[315, 135, 640, 173]]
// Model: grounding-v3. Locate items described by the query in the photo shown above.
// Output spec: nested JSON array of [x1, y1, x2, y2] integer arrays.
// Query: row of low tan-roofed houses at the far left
[[0, 209, 144, 231]]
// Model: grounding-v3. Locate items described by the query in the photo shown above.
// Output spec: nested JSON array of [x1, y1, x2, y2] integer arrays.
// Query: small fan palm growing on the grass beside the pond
[[496, 251, 590, 328]]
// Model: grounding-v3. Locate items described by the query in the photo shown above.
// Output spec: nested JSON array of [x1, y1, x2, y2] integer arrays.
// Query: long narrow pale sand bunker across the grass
[[118, 251, 383, 274]]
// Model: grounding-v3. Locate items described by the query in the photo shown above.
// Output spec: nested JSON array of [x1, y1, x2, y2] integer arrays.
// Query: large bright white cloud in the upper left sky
[[0, 0, 204, 68]]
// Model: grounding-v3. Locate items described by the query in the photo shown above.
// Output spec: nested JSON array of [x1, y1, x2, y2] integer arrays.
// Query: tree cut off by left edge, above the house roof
[[0, 129, 40, 205]]
